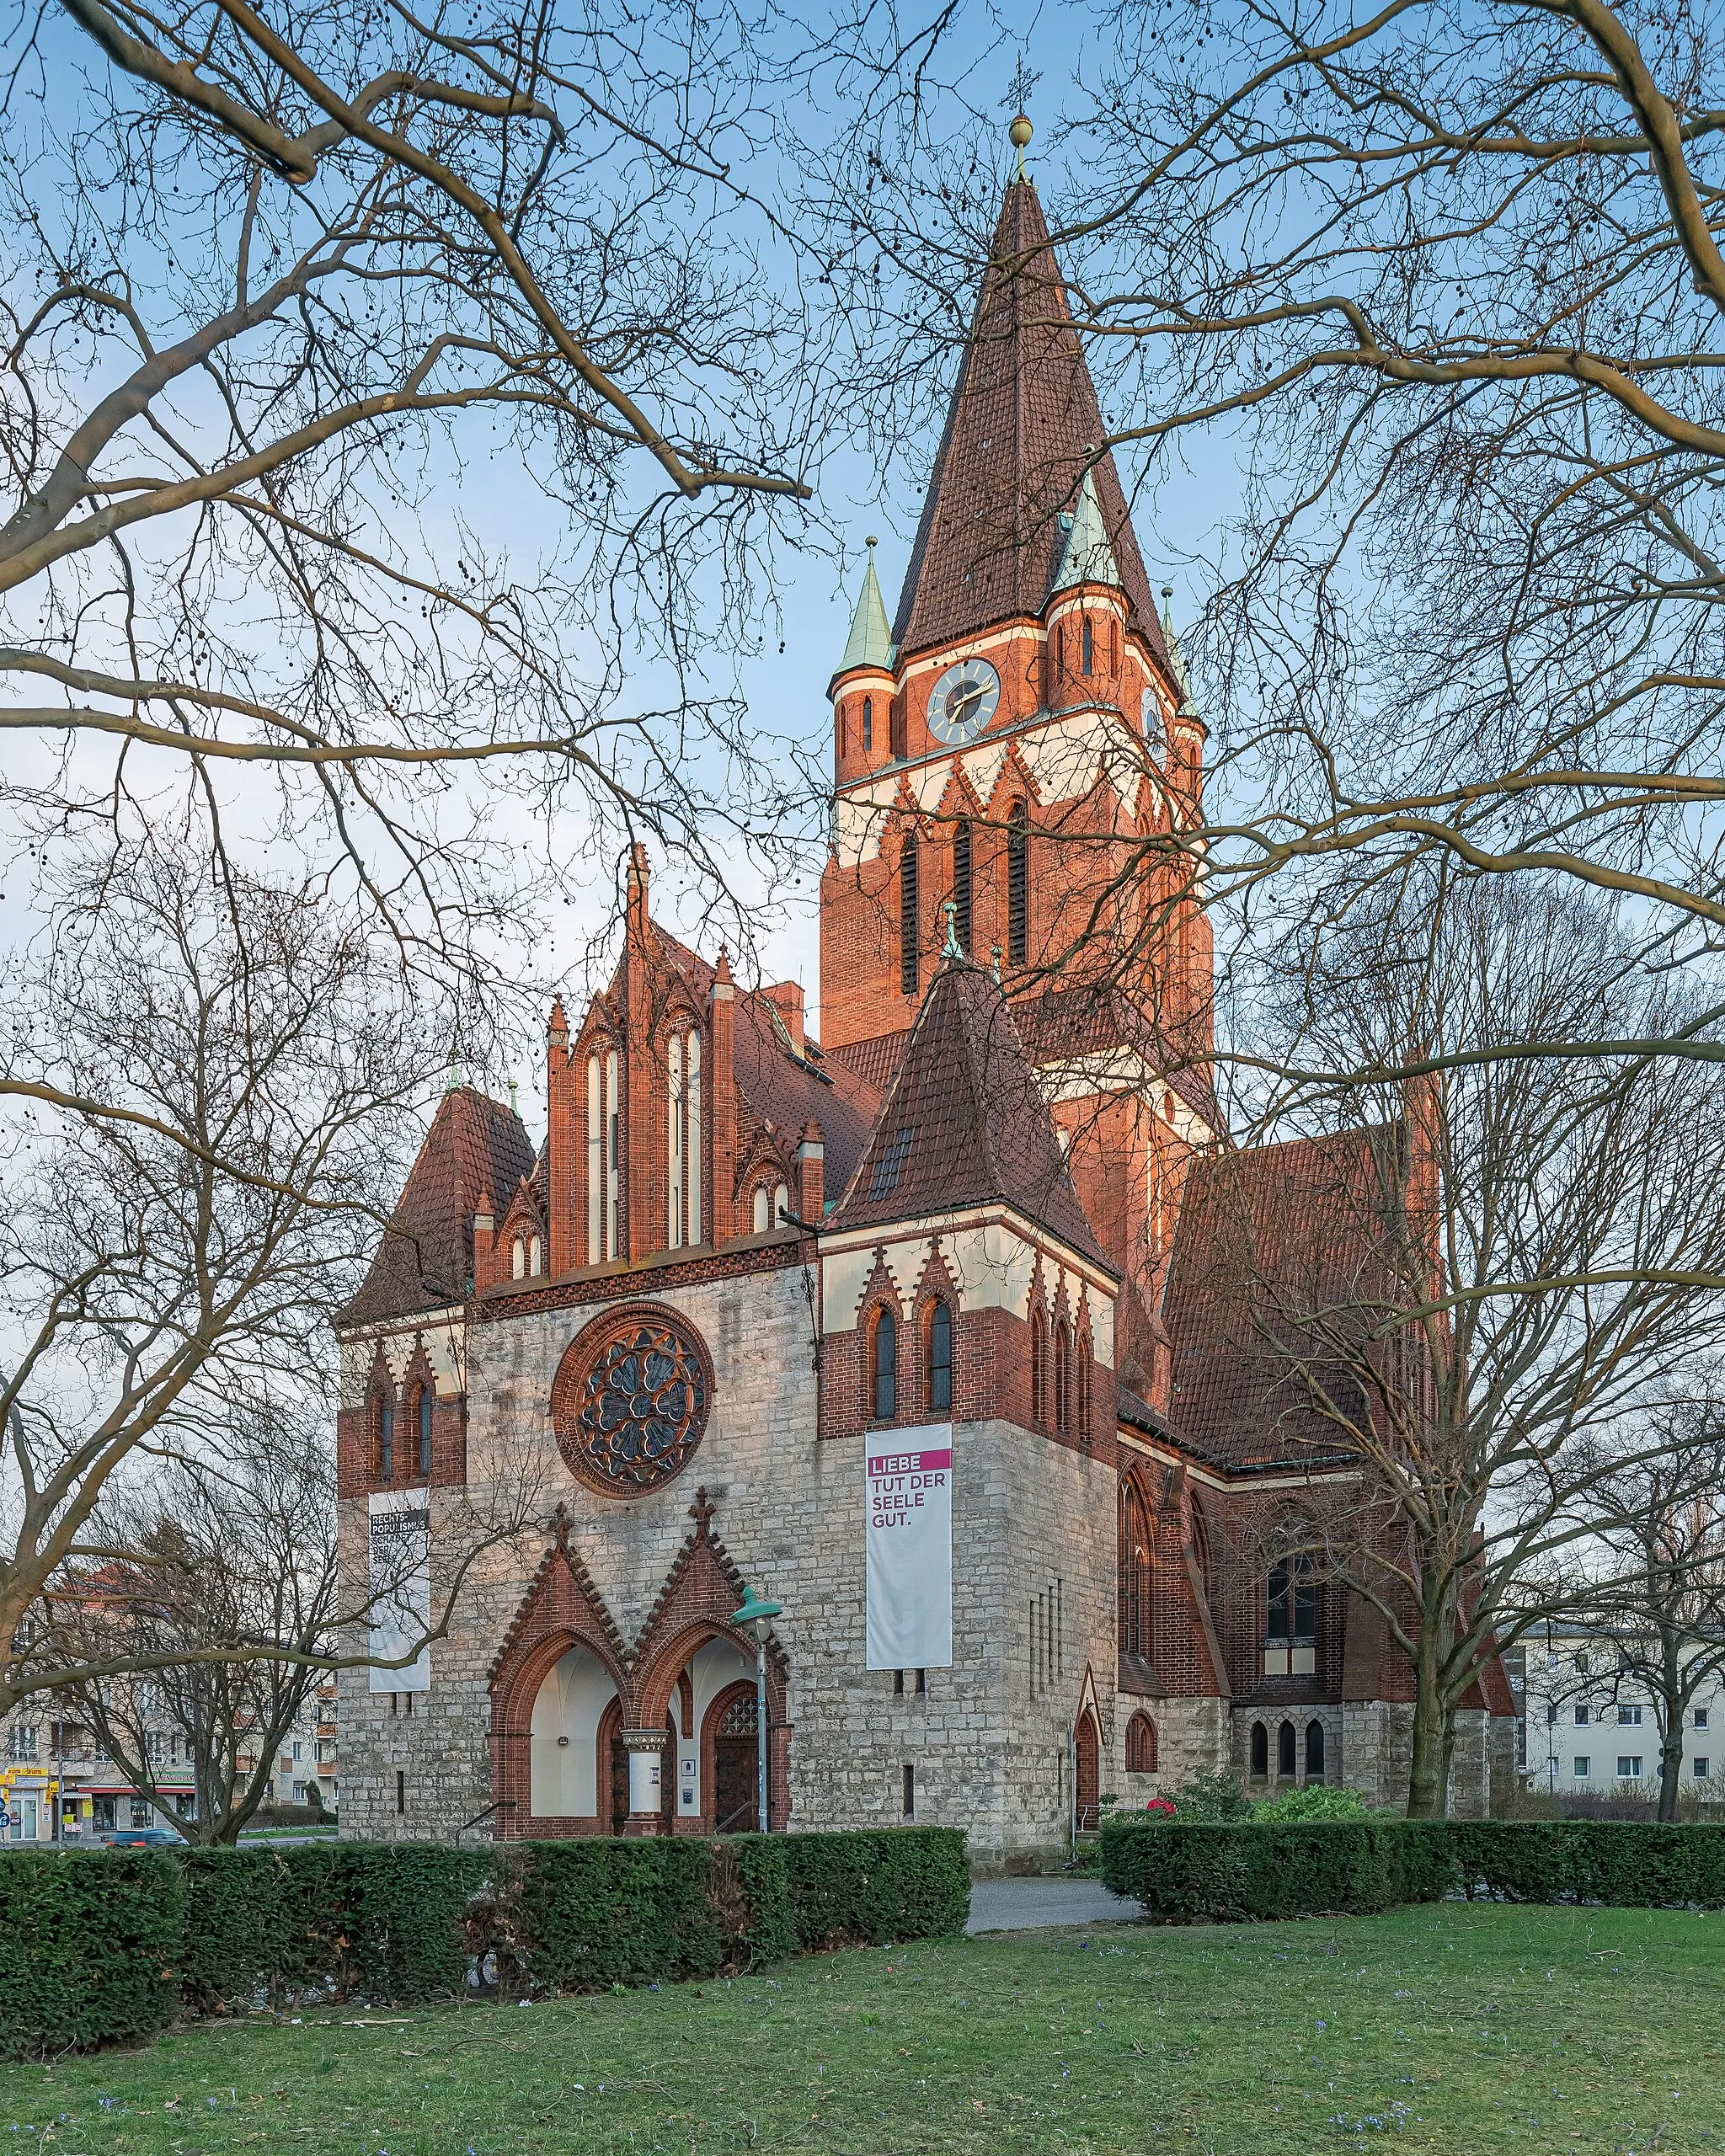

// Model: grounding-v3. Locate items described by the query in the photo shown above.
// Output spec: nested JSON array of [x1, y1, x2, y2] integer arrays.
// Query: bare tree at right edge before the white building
[[1585, 1422, 1725, 1820]]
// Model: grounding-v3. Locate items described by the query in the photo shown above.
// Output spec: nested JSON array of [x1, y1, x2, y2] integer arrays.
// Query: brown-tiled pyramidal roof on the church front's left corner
[[336, 1086, 532, 1326]]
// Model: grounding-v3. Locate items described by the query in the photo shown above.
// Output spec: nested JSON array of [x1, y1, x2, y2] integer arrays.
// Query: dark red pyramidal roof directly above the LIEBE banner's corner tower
[[830, 959, 1115, 1274]]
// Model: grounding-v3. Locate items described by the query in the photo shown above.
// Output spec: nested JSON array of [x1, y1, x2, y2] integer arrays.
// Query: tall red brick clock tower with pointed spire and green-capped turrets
[[821, 177, 1218, 1406]]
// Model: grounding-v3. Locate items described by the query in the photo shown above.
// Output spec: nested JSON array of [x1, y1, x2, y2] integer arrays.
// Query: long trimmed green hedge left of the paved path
[[0, 1826, 970, 2057]]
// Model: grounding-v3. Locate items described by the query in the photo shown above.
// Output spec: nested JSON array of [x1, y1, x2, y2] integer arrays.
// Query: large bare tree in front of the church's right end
[[1169, 875, 1725, 1816]]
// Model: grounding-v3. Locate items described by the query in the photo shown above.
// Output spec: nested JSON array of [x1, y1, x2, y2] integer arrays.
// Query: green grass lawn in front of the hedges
[[0, 1903, 1725, 2156]]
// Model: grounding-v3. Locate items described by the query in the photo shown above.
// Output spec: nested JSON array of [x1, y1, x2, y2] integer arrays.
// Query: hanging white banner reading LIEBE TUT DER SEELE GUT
[[862, 1423, 953, 1668]]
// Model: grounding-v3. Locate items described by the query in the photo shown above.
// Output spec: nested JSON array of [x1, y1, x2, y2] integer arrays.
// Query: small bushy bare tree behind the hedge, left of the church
[[43, 1414, 340, 1844]]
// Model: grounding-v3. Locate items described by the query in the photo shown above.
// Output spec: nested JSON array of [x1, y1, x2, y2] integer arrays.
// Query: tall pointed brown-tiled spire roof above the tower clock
[[893, 179, 1162, 655]]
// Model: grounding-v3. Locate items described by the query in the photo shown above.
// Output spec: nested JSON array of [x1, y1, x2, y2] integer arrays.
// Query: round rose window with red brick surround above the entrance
[[552, 1310, 712, 1497]]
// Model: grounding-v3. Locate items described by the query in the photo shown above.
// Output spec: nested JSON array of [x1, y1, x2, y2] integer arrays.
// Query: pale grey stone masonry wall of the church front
[[340, 1263, 1115, 1865]]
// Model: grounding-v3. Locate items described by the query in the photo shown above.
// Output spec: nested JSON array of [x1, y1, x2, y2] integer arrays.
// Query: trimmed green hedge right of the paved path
[[1102, 1813, 1725, 1924]]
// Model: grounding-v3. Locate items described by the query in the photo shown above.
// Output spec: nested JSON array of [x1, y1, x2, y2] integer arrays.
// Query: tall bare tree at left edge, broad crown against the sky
[[0, 847, 419, 1712]]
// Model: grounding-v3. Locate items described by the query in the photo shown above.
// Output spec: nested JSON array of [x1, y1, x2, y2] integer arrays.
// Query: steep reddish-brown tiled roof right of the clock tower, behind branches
[[1162, 1129, 1393, 1468]]
